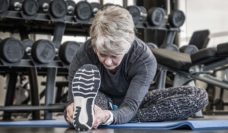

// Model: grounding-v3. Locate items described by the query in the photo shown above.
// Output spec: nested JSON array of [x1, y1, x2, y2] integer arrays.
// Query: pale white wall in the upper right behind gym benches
[[179, 0, 228, 47]]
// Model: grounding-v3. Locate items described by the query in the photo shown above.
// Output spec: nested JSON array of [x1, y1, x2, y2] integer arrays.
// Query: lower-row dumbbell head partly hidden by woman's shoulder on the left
[[59, 41, 80, 65]]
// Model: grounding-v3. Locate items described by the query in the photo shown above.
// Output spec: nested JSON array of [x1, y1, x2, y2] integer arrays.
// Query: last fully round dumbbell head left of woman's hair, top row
[[75, 1, 93, 20]]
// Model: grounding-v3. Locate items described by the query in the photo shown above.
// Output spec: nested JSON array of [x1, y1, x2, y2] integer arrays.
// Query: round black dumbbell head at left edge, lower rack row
[[0, 38, 24, 63]]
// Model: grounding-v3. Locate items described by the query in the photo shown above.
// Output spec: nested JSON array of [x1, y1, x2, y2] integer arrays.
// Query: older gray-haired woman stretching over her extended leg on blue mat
[[65, 6, 208, 130]]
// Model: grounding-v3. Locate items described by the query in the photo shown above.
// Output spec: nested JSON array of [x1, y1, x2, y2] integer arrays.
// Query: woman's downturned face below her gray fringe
[[95, 50, 124, 70]]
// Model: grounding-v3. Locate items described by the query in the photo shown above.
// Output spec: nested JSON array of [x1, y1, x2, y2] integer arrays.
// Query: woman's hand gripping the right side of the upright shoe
[[93, 105, 110, 129]]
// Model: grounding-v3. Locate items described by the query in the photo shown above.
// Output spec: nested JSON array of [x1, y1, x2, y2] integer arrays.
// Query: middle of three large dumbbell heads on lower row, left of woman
[[31, 40, 56, 64]]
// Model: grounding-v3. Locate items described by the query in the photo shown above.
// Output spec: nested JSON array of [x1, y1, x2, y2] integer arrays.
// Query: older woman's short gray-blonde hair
[[90, 6, 135, 55]]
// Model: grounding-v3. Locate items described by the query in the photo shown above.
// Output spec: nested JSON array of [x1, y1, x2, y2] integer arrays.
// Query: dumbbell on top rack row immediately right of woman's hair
[[127, 6, 147, 24]]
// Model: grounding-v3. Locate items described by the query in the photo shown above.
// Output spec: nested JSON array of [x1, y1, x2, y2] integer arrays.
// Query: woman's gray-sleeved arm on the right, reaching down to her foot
[[112, 53, 157, 124]]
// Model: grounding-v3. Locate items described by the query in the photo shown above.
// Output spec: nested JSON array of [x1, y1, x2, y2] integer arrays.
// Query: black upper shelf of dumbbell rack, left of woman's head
[[0, 11, 91, 35]]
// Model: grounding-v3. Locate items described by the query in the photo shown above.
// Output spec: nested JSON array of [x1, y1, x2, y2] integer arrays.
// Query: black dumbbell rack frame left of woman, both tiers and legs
[[0, 11, 74, 120]]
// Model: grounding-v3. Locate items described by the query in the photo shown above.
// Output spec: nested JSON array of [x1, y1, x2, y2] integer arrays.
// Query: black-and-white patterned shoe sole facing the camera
[[72, 65, 100, 131]]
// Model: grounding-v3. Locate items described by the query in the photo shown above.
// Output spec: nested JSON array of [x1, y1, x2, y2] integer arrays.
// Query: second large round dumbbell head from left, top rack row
[[22, 0, 39, 16]]
